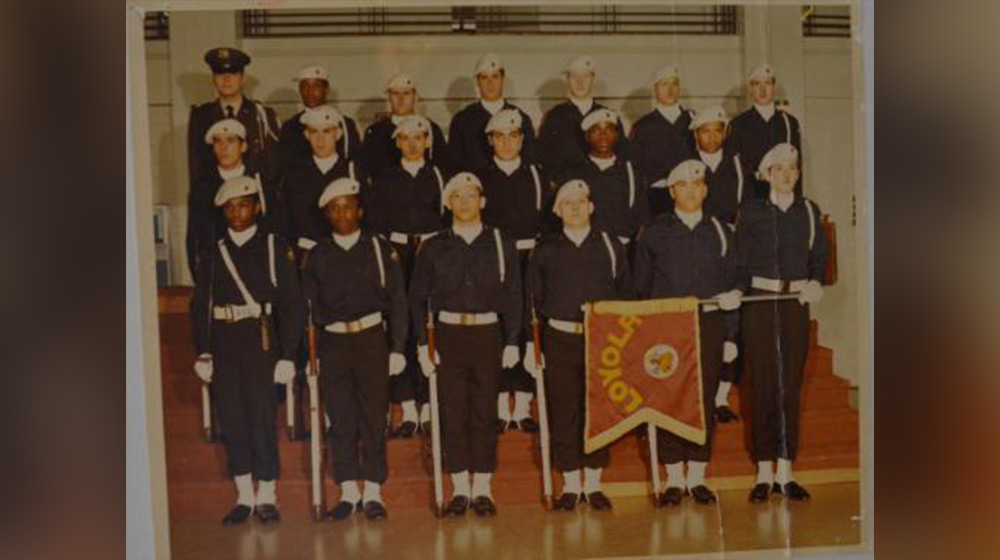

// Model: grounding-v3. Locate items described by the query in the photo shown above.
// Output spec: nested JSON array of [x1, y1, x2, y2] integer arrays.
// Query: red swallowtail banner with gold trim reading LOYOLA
[[583, 298, 705, 453]]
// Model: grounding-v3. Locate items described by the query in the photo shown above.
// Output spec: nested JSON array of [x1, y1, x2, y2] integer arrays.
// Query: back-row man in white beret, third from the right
[[538, 55, 628, 177]]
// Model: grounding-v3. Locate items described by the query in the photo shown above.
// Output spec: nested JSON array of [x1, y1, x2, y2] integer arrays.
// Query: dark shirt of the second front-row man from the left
[[302, 233, 409, 352]]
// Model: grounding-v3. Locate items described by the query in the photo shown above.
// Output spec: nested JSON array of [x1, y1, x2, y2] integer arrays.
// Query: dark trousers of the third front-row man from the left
[[436, 323, 503, 473]]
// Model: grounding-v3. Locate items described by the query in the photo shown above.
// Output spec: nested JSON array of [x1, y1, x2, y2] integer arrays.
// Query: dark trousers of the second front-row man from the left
[[319, 325, 389, 484]]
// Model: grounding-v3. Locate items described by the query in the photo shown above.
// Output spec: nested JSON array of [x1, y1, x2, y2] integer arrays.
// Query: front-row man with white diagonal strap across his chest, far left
[[191, 177, 305, 526]]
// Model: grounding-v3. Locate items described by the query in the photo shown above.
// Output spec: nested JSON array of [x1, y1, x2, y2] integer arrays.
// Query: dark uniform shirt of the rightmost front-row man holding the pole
[[736, 196, 827, 292]]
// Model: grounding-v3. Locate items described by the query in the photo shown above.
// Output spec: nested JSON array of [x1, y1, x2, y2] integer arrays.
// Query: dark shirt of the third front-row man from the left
[[410, 225, 524, 345]]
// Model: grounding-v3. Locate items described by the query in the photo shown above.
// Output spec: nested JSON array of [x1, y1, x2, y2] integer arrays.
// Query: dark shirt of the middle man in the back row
[[448, 100, 535, 173]]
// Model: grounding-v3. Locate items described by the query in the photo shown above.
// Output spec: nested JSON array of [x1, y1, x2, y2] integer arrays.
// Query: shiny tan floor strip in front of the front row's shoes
[[171, 483, 861, 560]]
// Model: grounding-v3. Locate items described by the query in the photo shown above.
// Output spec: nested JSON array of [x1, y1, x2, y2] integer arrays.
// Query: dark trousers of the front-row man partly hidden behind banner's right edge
[[656, 311, 726, 464]]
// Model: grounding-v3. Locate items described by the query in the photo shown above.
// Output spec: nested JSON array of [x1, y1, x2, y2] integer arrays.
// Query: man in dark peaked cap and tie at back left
[[188, 47, 280, 192]]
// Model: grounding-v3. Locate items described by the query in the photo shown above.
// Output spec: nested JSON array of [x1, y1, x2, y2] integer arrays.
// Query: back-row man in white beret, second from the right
[[632, 66, 694, 200]]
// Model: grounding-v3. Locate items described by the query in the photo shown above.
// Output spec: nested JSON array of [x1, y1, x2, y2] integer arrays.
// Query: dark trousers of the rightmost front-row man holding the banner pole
[[742, 290, 809, 461]]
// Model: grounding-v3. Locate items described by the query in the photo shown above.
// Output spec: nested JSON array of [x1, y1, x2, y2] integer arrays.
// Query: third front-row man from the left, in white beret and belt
[[410, 172, 523, 516]]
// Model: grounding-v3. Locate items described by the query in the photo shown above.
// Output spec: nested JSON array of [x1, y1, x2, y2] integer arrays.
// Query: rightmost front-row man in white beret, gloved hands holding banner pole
[[736, 144, 827, 503]]
